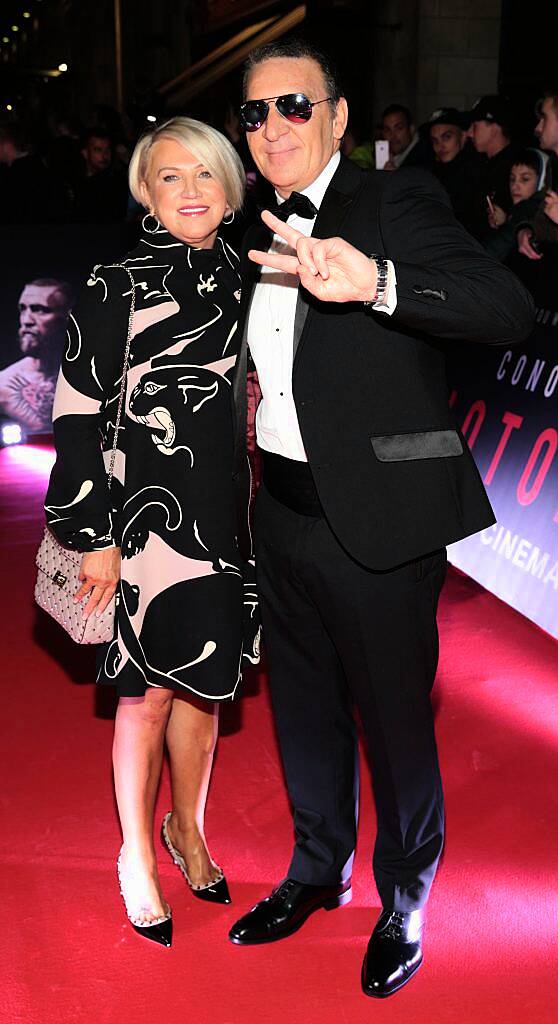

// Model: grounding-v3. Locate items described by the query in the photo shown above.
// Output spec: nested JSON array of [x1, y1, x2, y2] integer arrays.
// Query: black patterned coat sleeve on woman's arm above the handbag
[[45, 266, 131, 551]]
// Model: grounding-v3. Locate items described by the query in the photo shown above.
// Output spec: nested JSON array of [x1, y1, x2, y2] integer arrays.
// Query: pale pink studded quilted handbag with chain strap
[[35, 263, 135, 643]]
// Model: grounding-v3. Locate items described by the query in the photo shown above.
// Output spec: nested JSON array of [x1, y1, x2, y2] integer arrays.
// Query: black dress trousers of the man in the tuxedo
[[255, 477, 446, 911]]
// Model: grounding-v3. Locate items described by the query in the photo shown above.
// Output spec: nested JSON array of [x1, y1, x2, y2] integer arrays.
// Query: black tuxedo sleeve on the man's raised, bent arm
[[380, 168, 534, 344]]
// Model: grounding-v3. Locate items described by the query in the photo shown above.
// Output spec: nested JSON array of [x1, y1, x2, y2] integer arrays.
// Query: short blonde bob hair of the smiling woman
[[128, 118, 246, 212]]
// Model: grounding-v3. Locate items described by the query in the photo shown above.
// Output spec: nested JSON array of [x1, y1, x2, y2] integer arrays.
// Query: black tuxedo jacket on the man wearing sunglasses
[[233, 158, 534, 569]]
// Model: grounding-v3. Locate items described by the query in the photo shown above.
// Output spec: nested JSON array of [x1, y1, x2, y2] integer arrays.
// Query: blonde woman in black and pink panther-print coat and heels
[[45, 118, 259, 945]]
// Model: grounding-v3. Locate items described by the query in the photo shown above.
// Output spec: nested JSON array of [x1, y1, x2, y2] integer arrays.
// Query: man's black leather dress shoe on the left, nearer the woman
[[228, 879, 352, 946]]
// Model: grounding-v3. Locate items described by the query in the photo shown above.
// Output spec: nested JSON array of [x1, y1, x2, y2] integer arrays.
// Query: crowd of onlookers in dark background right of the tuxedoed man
[[345, 91, 558, 268]]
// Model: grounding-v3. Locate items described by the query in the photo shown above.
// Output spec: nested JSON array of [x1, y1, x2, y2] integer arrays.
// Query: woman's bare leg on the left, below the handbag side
[[113, 687, 173, 923]]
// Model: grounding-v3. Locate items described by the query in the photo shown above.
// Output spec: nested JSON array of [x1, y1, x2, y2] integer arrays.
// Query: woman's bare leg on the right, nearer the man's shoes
[[162, 695, 219, 886]]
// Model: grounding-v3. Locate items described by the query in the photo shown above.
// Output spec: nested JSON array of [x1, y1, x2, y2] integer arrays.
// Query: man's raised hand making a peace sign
[[248, 210, 378, 302]]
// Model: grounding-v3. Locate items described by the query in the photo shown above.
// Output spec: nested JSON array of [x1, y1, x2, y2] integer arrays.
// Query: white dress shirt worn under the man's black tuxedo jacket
[[247, 153, 397, 462]]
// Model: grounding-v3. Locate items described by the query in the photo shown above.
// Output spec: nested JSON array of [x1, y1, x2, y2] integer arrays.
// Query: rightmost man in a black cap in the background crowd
[[468, 95, 515, 234]]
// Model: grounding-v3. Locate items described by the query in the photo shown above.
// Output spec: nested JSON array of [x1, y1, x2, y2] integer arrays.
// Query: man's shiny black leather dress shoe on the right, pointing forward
[[362, 910, 424, 999]]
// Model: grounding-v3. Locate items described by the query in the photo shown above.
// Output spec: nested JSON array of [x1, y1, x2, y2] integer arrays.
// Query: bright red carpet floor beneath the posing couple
[[0, 446, 558, 1024]]
